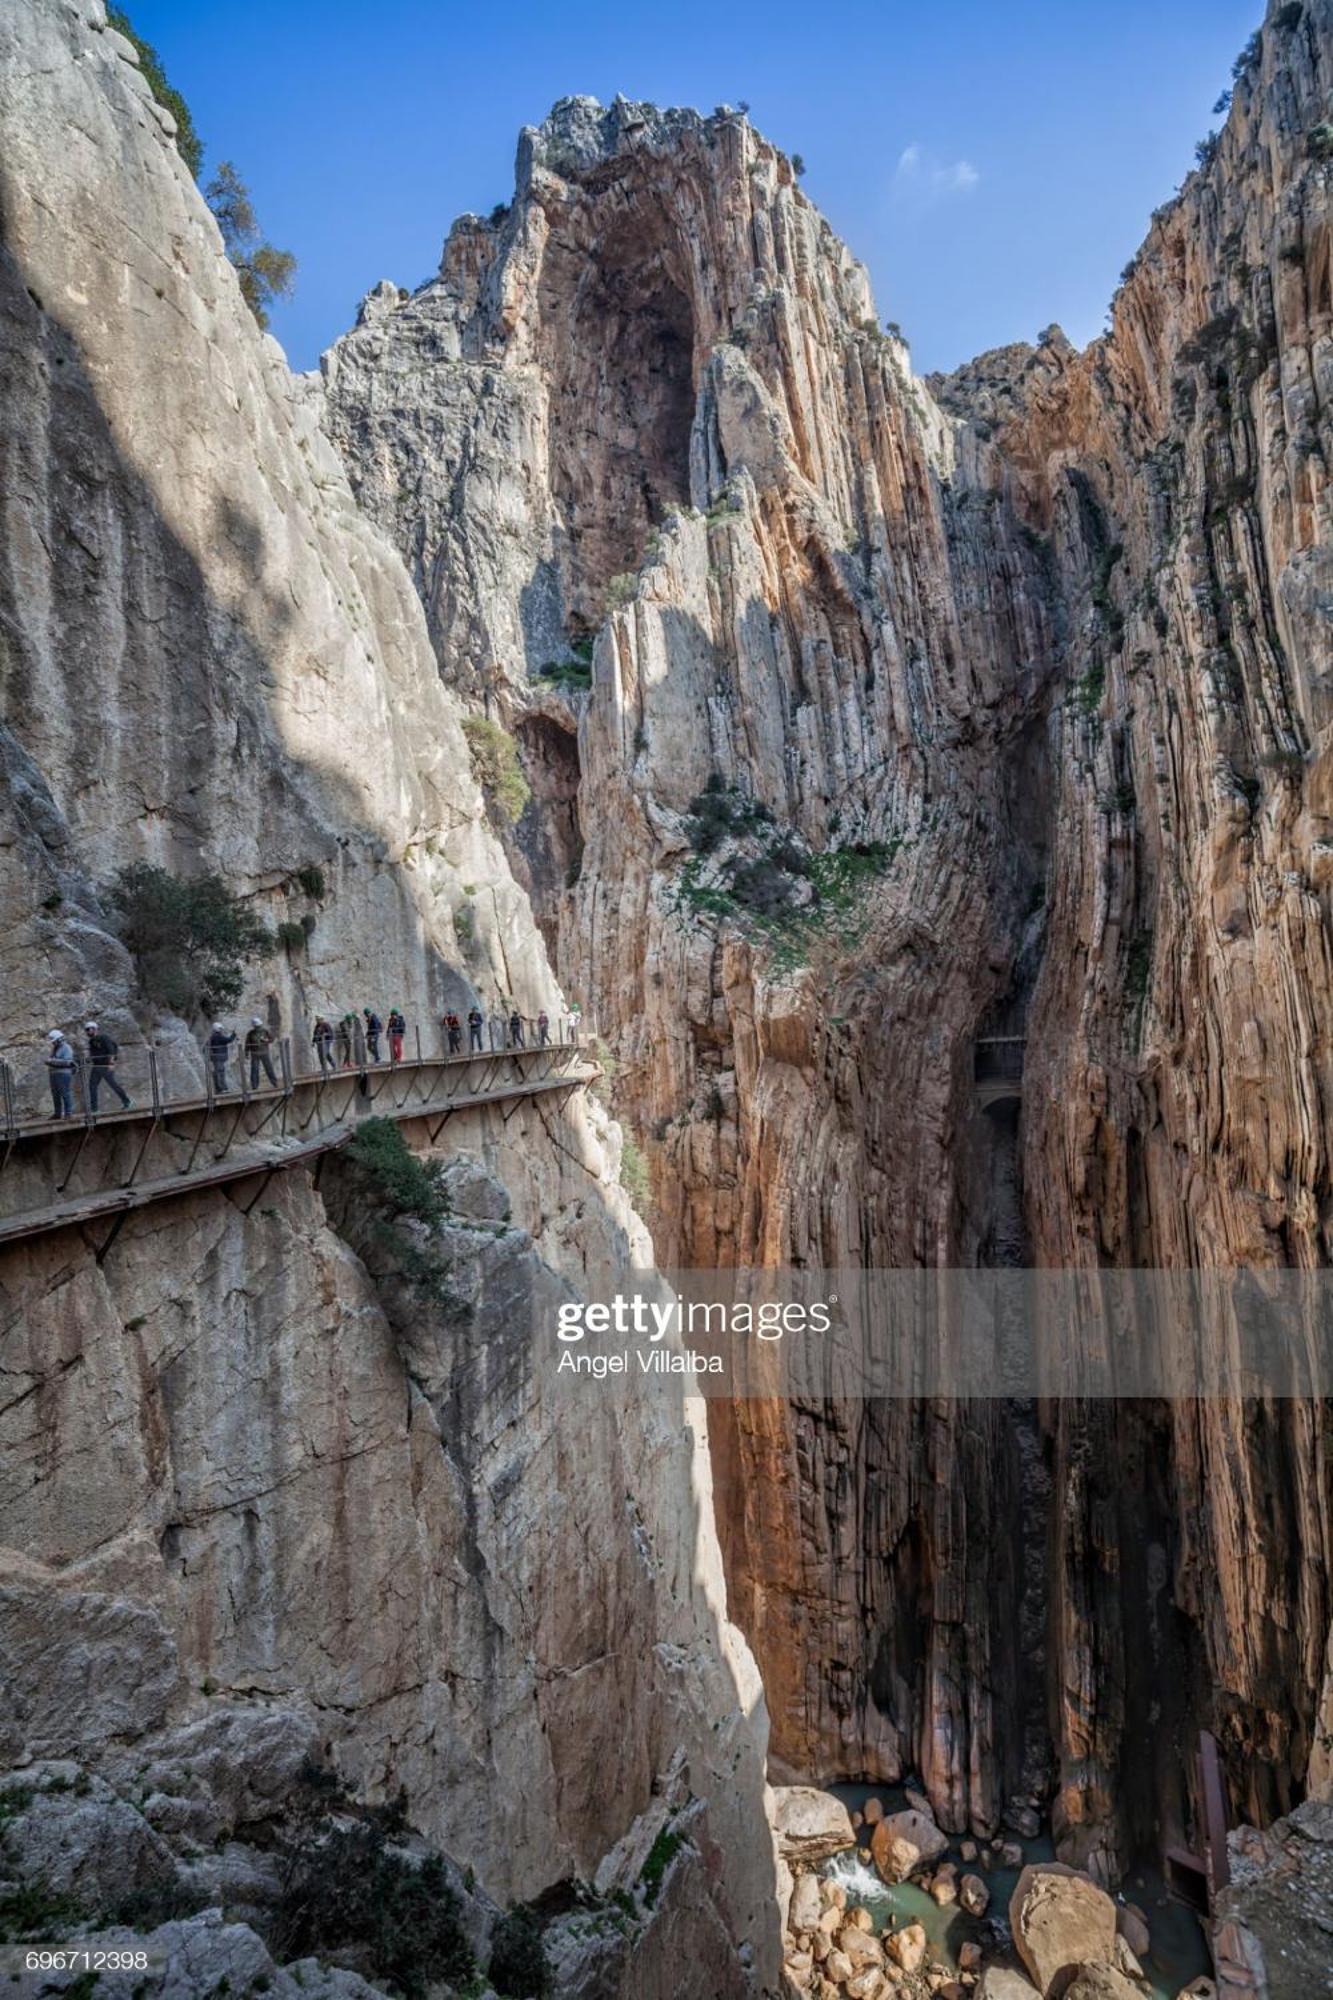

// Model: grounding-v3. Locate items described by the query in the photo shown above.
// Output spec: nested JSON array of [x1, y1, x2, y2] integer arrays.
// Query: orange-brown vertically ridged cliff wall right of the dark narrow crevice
[[943, 4, 1333, 1872]]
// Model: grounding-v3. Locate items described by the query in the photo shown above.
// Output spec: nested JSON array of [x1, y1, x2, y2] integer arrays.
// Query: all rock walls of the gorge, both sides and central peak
[[0, 0, 1333, 2000]]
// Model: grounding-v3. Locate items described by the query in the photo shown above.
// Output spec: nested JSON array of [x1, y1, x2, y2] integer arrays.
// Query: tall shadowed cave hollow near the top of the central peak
[[546, 204, 695, 626]]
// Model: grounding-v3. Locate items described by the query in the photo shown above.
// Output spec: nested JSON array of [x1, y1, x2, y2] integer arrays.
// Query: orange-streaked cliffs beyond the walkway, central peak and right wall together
[[324, 0, 1333, 1874]]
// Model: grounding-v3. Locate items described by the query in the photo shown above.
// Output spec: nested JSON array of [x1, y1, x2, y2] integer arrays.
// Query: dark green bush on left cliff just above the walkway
[[106, 862, 274, 1018]]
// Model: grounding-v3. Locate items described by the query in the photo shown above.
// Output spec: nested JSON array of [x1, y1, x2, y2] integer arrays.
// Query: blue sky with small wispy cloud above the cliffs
[[126, 0, 1261, 370]]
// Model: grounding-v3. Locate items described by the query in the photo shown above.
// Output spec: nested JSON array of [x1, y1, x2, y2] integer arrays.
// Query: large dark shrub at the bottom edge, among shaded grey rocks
[[272, 1824, 476, 2000]]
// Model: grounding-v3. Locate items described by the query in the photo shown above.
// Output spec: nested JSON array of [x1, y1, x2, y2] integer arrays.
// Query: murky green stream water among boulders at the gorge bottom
[[821, 1784, 1211, 2000]]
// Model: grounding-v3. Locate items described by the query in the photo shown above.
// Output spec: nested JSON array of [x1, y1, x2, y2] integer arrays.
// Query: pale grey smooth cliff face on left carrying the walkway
[[0, 0, 777, 2000]]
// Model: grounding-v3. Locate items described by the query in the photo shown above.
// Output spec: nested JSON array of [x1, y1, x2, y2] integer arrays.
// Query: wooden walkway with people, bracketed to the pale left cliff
[[0, 1042, 600, 1260]]
